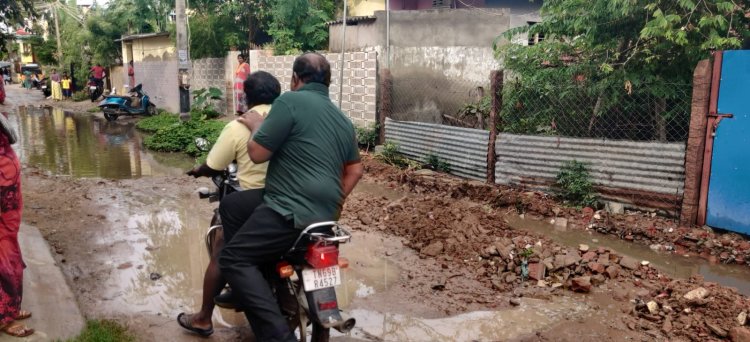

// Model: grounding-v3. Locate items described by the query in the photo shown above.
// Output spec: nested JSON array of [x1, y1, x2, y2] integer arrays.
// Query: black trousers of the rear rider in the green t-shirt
[[219, 204, 300, 342]]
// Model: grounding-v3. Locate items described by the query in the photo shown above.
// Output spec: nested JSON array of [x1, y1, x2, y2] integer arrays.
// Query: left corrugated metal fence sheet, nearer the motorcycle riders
[[385, 119, 490, 180]]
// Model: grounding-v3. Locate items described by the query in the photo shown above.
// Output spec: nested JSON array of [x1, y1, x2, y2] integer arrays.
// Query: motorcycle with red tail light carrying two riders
[[195, 138, 356, 342]]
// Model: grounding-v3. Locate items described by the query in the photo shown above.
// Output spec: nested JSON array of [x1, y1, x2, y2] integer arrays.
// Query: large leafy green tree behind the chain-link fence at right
[[495, 0, 750, 140]]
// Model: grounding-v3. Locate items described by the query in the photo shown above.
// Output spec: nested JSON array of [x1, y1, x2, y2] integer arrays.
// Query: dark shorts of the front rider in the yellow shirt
[[219, 188, 263, 243]]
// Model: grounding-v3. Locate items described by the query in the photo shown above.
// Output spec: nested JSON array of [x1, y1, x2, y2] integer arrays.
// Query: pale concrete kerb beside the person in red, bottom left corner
[[0, 224, 85, 342]]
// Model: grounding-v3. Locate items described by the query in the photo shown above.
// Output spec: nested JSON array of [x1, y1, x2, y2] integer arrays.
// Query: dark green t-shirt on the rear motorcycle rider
[[253, 83, 359, 228]]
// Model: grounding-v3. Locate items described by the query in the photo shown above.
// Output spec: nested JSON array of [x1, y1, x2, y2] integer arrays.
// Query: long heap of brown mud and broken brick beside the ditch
[[354, 157, 750, 341]]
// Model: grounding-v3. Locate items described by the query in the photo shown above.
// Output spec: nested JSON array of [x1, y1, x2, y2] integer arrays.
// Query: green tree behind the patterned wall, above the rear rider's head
[[268, 0, 336, 54]]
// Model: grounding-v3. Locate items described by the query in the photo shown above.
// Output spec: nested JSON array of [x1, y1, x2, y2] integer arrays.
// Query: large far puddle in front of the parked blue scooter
[[9, 106, 193, 179]]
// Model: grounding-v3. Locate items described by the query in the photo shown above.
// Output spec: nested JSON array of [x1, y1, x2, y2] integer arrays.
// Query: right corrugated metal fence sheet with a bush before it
[[495, 134, 685, 212]]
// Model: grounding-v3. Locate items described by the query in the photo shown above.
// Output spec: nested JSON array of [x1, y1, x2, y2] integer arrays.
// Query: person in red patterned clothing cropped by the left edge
[[0, 114, 34, 337]]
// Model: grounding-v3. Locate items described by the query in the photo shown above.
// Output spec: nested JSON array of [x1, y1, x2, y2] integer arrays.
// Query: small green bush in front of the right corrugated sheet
[[556, 160, 597, 207]]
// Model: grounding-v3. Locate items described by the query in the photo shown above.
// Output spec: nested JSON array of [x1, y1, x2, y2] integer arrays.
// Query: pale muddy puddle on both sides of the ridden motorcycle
[[98, 191, 400, 326]]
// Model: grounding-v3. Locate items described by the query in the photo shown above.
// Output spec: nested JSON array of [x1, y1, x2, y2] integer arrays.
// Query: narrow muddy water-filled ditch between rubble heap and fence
[[505, 215, 750, 296]]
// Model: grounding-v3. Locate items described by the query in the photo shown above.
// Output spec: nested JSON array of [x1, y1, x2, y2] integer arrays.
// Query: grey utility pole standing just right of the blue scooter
[[174, 0, 190, 121]]
